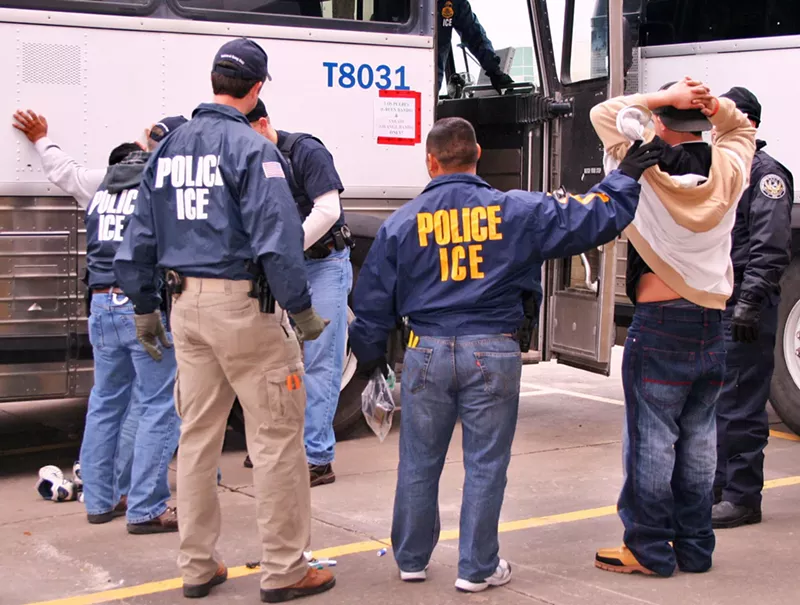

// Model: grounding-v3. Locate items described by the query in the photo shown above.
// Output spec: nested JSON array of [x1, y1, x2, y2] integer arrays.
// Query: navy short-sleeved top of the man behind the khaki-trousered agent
[[277, 130, 344, 235]]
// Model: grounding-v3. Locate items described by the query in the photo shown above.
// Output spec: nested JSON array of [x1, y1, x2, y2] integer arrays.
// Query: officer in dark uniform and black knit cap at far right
[[711, 86, 794, 529]]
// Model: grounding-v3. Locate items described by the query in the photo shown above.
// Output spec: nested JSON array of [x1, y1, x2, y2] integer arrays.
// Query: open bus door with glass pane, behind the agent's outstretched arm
[[532, 0, 623, 375]]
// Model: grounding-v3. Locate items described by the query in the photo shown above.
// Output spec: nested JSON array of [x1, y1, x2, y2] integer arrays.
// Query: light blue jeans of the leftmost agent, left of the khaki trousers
[[80, 294, 179, 523]]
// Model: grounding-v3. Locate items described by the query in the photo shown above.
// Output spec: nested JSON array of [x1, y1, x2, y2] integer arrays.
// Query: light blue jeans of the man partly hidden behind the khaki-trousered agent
[[303, 248, 353, 464]]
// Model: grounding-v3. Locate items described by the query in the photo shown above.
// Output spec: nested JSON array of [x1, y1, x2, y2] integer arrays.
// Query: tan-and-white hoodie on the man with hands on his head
[[591, 95, 756, 309]]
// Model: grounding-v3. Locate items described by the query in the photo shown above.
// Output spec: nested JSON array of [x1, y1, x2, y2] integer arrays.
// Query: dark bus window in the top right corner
[[639, 0, 800, 46]]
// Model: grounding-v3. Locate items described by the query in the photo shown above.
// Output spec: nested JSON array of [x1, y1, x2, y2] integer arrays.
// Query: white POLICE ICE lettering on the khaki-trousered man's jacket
[[154, 155, 223, 221]]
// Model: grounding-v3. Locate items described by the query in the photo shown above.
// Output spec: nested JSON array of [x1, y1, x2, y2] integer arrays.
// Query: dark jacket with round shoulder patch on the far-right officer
[[730, 141, 794, 305]]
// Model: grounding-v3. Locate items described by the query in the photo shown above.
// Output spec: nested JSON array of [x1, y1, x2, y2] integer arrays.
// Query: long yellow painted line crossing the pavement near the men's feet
[[23, 475, 800, 605]]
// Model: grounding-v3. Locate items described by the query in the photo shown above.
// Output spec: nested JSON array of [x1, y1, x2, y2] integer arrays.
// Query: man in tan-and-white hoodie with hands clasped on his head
[[591, 78, 755, 576]]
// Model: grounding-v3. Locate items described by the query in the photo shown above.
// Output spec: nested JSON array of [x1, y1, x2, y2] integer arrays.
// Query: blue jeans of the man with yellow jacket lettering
[[392, 334, 522, 582]]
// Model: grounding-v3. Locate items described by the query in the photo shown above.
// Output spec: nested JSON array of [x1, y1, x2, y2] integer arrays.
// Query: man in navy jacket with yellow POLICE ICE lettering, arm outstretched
[[350, 118, 659, 592]]
